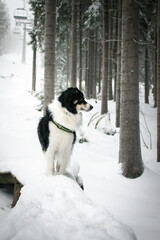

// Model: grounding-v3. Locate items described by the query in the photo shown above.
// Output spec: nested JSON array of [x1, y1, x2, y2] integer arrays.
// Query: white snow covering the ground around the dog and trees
[[0, 51, 160, 240]]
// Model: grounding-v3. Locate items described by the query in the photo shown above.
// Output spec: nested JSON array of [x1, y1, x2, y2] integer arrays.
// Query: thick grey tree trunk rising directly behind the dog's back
[[43, 0, 56, 113]]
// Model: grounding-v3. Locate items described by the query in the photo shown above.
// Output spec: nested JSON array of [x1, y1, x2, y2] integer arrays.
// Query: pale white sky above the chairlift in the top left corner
[[3, 0, 28, 29]]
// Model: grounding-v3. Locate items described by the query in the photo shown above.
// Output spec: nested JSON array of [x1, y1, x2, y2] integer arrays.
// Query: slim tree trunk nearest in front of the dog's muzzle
[[101, 0, 109, 114]]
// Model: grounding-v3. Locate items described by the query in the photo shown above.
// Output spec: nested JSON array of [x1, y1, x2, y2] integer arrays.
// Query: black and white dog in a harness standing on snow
[[38, 88, 93, 175]]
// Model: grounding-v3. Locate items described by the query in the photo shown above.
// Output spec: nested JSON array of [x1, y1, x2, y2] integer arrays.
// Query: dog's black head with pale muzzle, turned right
[[58, 88, 93, 114]]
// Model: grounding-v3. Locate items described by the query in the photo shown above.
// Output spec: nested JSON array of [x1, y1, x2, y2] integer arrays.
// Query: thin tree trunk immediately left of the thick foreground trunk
[[116, 0, 122, 127]]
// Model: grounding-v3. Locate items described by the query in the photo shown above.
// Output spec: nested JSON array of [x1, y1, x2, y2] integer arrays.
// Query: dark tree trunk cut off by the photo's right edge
[[157, 1, 160, 162]]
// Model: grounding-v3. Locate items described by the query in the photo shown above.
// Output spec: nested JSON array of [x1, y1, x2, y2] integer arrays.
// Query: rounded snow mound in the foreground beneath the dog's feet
[[0, 176, 136, 240]]
